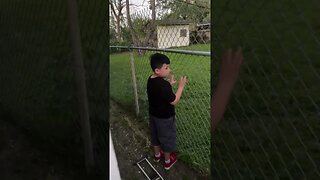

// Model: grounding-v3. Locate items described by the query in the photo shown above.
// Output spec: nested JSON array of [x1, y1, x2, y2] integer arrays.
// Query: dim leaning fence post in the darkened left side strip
[[68, 0, 94, 174]]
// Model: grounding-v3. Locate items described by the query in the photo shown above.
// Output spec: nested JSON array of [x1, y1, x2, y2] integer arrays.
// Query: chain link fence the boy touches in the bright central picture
[[110, 2, 211, 173]]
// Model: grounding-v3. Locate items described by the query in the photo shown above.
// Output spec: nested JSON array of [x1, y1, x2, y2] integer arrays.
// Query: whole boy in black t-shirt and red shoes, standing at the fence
[[147, 53, 187, 170]]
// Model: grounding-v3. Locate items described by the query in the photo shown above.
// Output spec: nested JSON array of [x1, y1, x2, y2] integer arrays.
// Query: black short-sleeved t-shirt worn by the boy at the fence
[[147, 76, 176, 118]]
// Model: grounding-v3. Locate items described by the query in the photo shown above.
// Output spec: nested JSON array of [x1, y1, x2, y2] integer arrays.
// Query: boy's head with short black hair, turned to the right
[[150, 53, 170, 77]]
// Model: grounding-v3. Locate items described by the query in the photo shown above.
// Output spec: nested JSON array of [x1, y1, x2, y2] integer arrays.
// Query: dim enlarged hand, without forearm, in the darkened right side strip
[[219, 48, 243, 87]]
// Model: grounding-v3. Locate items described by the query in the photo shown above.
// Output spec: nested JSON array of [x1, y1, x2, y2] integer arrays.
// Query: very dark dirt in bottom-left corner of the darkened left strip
[[0, 118, 84, 180]]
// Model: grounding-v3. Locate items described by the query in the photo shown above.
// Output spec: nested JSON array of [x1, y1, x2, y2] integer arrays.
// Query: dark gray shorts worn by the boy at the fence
[[149, 115, 177, 152]]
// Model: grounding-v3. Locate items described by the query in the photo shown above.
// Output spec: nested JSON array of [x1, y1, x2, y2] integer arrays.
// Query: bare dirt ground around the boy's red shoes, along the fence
[[109, 101, 209, 180]]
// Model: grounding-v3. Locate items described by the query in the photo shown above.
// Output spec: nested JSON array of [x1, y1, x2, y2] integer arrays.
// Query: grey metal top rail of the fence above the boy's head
[[110, 46, 210, 56]]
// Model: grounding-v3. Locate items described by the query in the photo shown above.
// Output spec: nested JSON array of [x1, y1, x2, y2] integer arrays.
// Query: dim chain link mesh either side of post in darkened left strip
[[0, 0, 108, 179]]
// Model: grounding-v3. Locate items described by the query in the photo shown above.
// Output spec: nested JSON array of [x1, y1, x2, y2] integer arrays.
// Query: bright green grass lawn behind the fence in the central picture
[[110, 45, 210, 172]]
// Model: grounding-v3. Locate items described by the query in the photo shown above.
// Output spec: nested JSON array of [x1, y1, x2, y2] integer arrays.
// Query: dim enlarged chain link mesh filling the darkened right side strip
[[212, 0, 320, 179]]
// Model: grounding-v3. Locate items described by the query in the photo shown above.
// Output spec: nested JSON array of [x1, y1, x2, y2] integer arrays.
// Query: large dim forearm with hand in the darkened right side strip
[[211, 48, 243, 130]]
